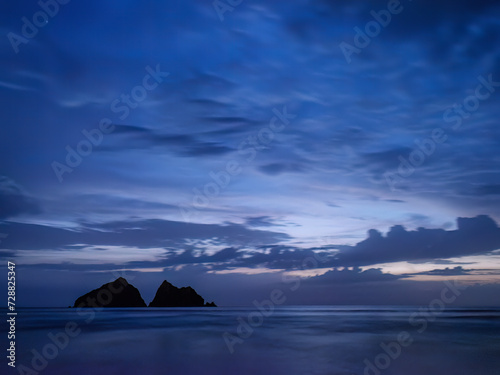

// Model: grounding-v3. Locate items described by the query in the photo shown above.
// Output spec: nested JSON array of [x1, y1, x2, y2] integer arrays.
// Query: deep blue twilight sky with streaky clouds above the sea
[[0, 0, 500, 306]]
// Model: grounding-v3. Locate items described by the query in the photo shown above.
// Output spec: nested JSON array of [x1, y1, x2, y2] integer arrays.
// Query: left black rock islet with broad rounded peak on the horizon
[[73, 277, 146, 307]]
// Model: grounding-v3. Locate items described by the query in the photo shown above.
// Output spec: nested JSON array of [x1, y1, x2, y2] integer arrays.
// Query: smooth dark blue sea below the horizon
[[6, 306, 500, 375]]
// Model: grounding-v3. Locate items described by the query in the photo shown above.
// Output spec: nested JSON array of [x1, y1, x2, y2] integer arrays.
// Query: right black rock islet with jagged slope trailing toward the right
[[149, 280, 216, 307]]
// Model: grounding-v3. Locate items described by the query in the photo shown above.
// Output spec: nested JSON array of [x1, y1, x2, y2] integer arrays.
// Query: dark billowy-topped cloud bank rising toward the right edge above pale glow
[[200, 216, 500, 269]]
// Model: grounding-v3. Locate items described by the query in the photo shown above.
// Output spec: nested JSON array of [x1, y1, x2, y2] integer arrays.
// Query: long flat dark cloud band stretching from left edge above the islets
[[0, 219, 289, 251]]
